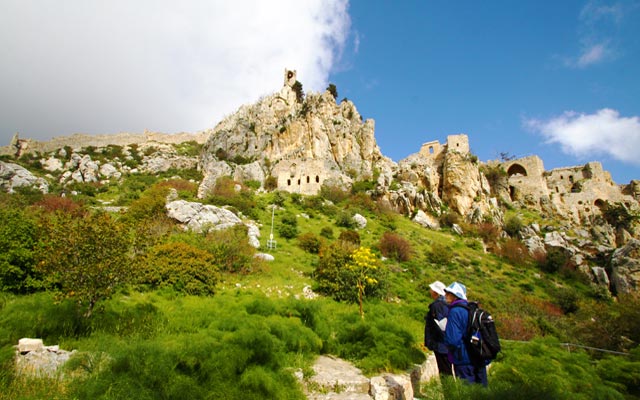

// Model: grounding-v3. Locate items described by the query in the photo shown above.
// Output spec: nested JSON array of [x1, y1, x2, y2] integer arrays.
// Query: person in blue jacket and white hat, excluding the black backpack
[[444, 282, 488, 386]]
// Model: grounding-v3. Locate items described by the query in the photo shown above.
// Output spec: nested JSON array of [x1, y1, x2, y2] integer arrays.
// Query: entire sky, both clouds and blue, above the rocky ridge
[[0, 0, 640, 184]]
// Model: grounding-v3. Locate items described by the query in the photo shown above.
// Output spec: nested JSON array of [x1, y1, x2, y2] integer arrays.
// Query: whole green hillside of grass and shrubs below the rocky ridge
[[0, 161, 640, 399]]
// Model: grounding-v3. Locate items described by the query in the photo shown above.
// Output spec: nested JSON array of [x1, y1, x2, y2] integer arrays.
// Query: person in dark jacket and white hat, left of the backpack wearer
[[424, 281, 453, 375]]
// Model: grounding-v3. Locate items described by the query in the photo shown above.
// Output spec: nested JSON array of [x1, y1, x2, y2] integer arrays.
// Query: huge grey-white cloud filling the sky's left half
[[0, 0, 350, 145]]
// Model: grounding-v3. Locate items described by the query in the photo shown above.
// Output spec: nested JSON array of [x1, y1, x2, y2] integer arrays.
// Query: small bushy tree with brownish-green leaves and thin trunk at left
[[38, 213, 132, 318]]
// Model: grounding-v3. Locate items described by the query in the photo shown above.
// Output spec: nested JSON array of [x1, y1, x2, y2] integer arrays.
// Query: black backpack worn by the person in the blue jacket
[[464, 301, 500, 365]]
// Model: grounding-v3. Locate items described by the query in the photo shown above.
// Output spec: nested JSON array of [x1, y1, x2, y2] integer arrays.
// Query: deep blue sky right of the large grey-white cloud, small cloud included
[[331, 0, 640, 183]]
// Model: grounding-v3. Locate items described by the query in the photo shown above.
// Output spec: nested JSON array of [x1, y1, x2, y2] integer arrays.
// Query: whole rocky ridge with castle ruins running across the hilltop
[[0, 70, 640, 292]]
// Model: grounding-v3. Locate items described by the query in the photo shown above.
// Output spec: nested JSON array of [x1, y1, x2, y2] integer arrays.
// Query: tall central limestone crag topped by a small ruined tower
[[199, 71, 395, 197]]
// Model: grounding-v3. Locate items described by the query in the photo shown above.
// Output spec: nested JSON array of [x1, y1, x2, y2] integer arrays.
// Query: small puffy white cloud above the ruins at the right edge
[[524, 108, 640, 165]]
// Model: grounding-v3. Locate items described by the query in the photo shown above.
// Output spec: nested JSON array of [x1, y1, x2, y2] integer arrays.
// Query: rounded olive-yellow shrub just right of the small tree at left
[[140, 242, 218, 295]]
